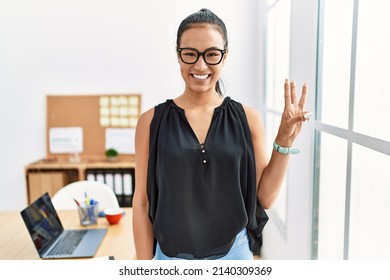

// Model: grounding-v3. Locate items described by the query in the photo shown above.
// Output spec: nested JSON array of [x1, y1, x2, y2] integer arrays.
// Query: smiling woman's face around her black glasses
[[177, 25, 227, 97]]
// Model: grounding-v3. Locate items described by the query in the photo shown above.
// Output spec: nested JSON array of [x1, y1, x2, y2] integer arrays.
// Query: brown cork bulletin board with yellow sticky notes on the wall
[[46, 94, 141, 159]]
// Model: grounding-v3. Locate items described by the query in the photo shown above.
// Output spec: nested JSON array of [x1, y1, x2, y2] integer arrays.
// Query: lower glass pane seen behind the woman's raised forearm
[[266, 113, 287, 226]]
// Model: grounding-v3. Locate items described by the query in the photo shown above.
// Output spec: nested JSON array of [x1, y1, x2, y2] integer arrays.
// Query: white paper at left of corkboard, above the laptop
[[49, 127, 83, 154]]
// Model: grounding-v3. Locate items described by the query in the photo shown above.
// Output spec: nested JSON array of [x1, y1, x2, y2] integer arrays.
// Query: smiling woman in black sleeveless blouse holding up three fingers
[[133, 9, 307, 259]]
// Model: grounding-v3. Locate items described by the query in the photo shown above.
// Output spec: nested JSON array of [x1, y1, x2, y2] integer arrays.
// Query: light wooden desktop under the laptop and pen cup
[[0, 208, 135, 260]]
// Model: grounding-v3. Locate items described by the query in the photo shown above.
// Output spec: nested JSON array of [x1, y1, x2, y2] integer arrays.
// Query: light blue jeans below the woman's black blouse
[[154, 228, 253, 260]]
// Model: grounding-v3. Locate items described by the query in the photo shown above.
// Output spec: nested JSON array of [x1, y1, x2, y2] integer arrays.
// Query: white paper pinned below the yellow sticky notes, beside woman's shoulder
[[105, 128, 135, 154]]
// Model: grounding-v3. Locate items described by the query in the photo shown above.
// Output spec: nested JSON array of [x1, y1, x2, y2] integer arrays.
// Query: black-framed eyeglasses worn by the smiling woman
[[177, 48, 226, 65]]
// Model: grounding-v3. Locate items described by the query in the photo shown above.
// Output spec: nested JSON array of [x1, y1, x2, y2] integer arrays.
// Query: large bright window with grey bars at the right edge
[[313, 0, 390, 259]]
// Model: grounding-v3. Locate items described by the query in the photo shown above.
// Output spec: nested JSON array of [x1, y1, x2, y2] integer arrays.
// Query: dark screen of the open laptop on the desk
[[21, 193, 64, 254]]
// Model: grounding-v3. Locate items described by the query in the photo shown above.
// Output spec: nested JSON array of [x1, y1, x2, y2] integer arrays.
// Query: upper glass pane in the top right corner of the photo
[[354, 0, 390, 141]]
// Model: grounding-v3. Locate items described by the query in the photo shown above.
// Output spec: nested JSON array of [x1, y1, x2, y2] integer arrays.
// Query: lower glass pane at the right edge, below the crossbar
[[349, 144, 390, 259]]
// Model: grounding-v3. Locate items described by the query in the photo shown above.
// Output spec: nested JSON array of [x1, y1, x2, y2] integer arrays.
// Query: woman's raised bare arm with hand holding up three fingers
[[245, 80, 307, 209]]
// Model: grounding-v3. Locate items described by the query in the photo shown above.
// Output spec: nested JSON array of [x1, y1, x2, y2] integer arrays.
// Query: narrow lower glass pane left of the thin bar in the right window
[[318, 132, 347, 259]]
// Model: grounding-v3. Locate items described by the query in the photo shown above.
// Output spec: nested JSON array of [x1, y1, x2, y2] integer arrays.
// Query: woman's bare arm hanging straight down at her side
[[133, 106, 154, 260]]
